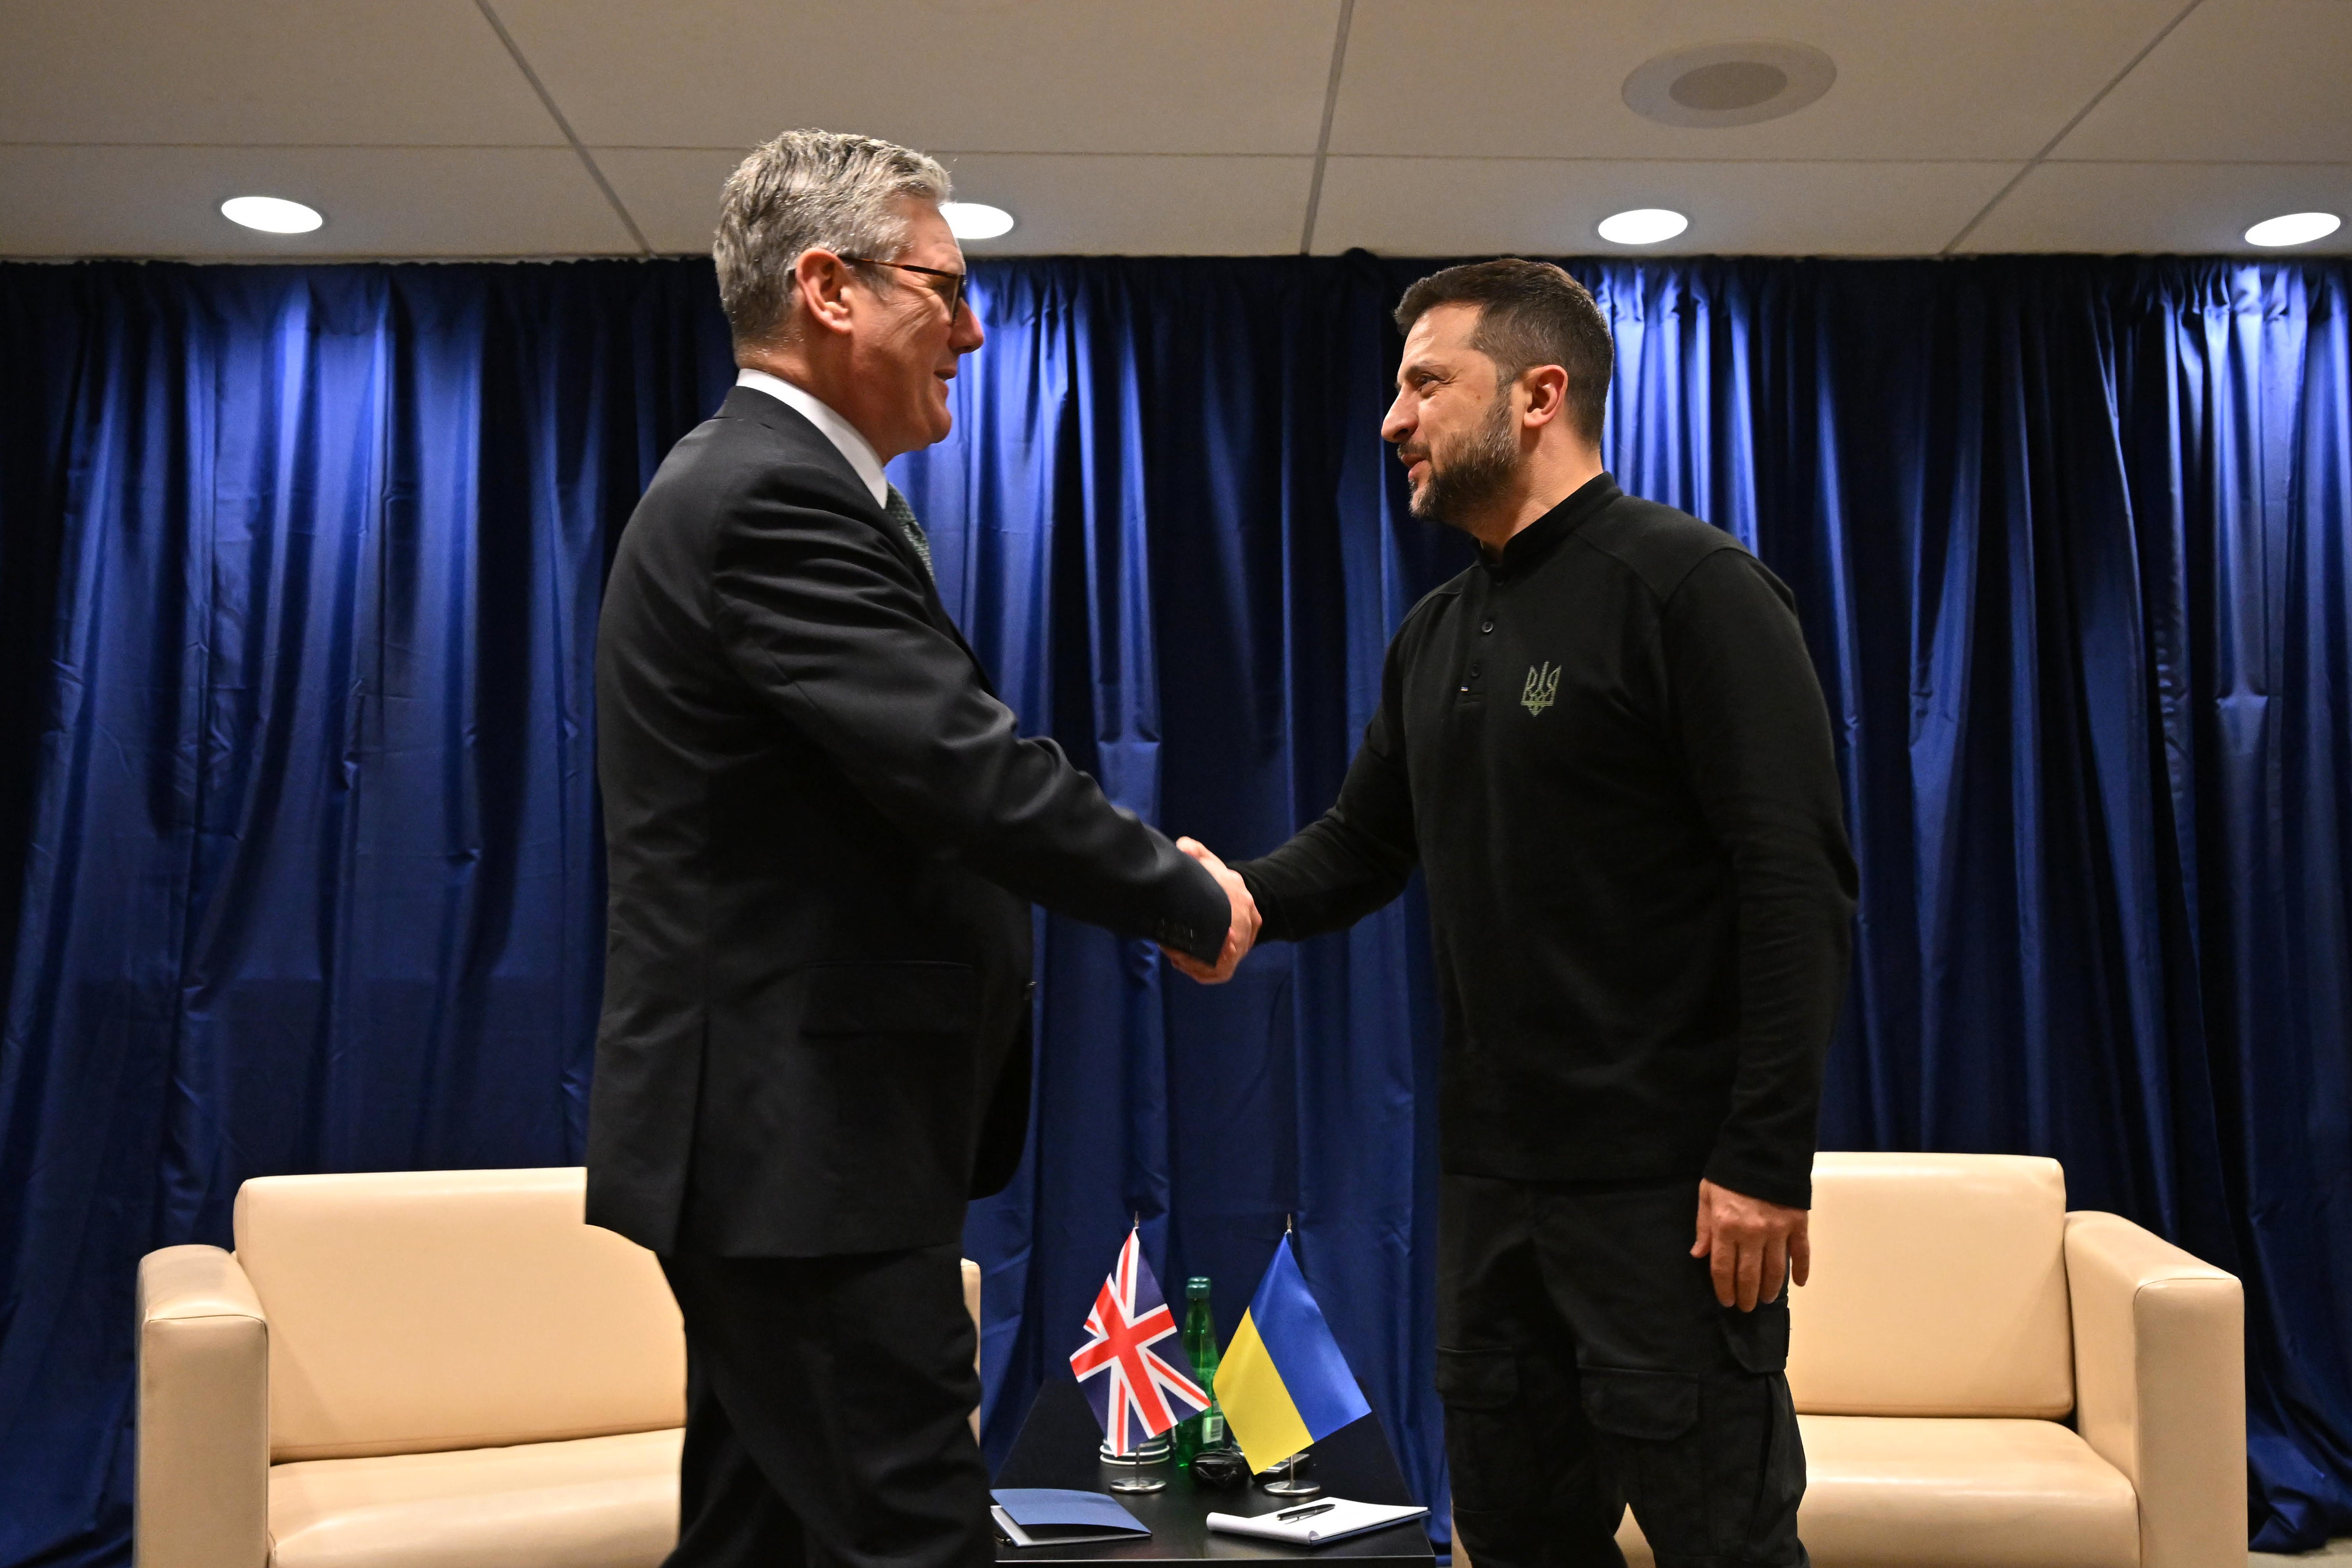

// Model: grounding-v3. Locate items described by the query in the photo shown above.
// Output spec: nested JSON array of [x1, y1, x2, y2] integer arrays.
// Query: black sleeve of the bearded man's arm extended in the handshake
[[1232, 644, 1421, 943]]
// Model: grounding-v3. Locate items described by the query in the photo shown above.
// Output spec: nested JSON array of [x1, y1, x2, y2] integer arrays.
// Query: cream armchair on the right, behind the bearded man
[[1618, 1154, 2246, 1568]]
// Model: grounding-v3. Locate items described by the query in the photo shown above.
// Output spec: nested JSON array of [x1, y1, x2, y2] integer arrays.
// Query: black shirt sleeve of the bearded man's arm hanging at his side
[[1661, 550, 1856, 1208]]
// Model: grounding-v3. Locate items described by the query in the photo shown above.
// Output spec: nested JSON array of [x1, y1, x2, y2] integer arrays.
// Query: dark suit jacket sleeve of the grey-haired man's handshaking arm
[[713, 472, 1232, 961]]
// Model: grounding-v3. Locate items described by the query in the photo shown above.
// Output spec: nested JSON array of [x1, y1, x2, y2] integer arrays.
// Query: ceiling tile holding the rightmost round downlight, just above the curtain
[[1966, 162, 2352, 256]]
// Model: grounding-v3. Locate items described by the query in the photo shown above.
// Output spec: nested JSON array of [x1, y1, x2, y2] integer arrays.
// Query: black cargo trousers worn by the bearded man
[[1437, 1175, 1809, 1568]]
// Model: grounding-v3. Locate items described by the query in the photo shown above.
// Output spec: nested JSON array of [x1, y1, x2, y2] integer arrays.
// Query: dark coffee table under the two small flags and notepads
[[997, 1366, 1435, 1568]]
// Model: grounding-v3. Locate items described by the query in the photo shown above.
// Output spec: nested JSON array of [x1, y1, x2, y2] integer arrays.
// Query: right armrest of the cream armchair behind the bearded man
[[2065, 1211, 2246, 1568]]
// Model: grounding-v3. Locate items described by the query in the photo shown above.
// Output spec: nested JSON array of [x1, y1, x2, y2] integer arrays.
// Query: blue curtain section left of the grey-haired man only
[[0, 266, 727, 1563]]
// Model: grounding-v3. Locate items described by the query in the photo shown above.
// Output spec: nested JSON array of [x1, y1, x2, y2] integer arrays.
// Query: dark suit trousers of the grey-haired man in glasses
[[661, 1244, 995, 1568]]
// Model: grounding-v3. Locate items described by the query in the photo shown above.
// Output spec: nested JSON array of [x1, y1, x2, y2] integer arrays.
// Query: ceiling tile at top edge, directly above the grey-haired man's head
[[496, 0, 1340, 153]]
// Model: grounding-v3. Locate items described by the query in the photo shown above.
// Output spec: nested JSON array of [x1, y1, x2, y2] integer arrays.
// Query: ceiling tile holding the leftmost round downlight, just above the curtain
[[0, 146, 637, 261]]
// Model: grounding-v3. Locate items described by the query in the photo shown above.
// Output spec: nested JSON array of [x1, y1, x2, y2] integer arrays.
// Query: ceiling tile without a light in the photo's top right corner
[[2053, 0, 2352, 162]]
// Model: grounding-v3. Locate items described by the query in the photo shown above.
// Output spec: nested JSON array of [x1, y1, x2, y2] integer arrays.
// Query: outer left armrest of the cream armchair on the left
[[132, 1246, 271, 1568]]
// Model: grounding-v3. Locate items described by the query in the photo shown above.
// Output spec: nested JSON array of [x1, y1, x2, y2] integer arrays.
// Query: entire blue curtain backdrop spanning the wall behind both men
[[0, 256, 2352, 1563]]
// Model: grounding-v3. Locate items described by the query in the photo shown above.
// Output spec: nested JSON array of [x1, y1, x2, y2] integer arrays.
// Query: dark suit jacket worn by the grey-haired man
[[588, 388, 1228, 1258]]
